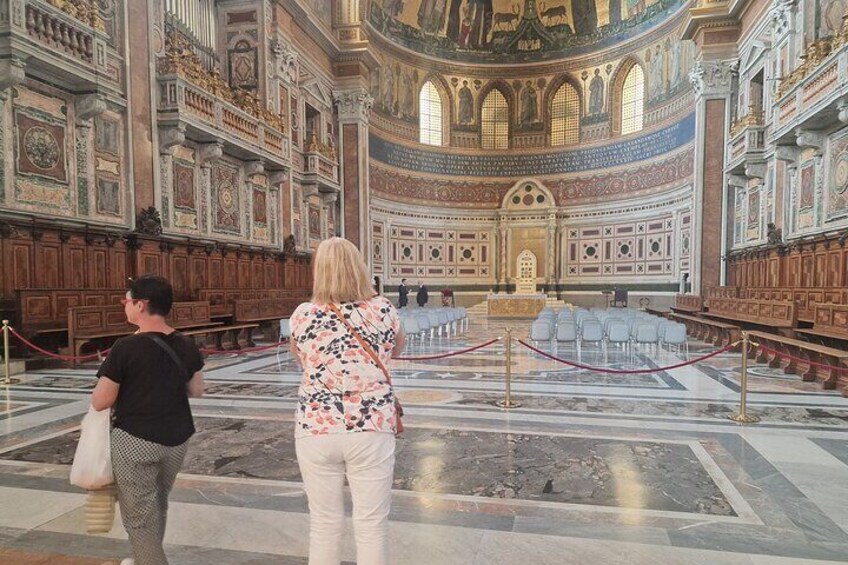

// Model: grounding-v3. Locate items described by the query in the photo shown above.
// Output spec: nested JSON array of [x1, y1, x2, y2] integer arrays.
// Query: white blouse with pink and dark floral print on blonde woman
[[291, 296, 400, 438]]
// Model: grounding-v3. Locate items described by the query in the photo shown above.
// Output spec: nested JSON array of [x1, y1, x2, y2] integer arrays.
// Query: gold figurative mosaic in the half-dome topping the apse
[[369, 0, 684, 63]]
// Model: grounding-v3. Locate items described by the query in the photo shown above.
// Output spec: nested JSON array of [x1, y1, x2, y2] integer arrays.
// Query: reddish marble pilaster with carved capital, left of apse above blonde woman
[[334, 88, 374, 253]]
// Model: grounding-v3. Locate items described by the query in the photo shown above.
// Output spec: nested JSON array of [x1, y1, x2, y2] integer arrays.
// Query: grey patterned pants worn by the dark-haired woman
[[112, 428, 188, 565]]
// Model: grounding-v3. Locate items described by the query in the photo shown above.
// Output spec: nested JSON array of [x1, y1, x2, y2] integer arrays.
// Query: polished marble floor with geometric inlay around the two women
[[0, 310, 848, 565]]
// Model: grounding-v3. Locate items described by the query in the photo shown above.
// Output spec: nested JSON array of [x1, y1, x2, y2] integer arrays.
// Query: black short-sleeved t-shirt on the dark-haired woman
[[97, 332, 203, 446]]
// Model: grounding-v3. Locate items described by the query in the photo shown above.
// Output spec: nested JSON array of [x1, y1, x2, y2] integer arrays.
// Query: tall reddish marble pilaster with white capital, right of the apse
[[689, 60, 737, 294]]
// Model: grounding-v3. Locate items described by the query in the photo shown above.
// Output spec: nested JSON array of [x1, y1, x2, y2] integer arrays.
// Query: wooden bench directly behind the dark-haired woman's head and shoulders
[[68, 301, 258, 357]]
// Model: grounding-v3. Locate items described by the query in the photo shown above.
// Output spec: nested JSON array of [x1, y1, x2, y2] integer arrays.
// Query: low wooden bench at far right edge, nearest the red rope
[[748, 331, 848, 396]]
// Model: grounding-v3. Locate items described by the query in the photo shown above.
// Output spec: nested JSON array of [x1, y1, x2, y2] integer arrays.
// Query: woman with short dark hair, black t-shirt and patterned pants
[[91, 276, 203, 565]]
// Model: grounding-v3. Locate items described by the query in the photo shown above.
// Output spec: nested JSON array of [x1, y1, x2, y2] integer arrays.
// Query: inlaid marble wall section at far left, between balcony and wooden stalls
[[0, 79, 131, 226]]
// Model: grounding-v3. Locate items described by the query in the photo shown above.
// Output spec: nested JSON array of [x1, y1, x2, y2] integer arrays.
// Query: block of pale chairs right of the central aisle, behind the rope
[[530, 308, 689, 355]]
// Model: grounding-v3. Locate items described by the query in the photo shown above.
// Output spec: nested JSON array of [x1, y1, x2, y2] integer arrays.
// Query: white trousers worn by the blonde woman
[[295, 432, 395, 565]]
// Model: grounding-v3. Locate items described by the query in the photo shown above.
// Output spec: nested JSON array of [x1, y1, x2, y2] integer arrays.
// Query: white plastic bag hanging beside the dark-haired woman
[[71, 406, 115, 490]]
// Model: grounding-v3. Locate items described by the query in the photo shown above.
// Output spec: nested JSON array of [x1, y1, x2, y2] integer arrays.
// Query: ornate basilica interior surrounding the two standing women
[[0, 0, 848, 565]]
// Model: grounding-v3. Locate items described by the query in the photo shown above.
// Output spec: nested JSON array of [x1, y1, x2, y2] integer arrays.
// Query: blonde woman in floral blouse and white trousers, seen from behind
[[291, 237, 404, 565]]
